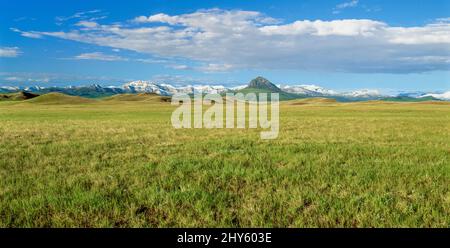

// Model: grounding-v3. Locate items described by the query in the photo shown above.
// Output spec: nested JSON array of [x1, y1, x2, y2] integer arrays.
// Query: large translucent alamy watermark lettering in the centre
[[171, 93, 280, 139]]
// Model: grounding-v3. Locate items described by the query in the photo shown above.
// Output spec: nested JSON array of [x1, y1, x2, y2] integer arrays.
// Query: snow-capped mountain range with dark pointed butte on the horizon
[[0, 77, 450, 101]]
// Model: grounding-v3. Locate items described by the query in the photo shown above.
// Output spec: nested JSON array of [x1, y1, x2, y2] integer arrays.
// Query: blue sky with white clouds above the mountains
[[0, 0, 450, 92]]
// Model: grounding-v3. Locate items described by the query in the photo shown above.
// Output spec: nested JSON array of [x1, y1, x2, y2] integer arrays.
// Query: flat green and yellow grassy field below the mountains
[[0, 98, 450, 227]]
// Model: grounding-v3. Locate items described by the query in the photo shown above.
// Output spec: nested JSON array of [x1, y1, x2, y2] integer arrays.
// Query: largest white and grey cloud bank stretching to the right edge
[[15, 9, 450, 73]]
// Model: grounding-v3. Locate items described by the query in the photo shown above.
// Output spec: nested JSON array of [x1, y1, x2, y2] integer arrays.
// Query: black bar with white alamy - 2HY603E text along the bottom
[[0, 228, 450, 247]]
